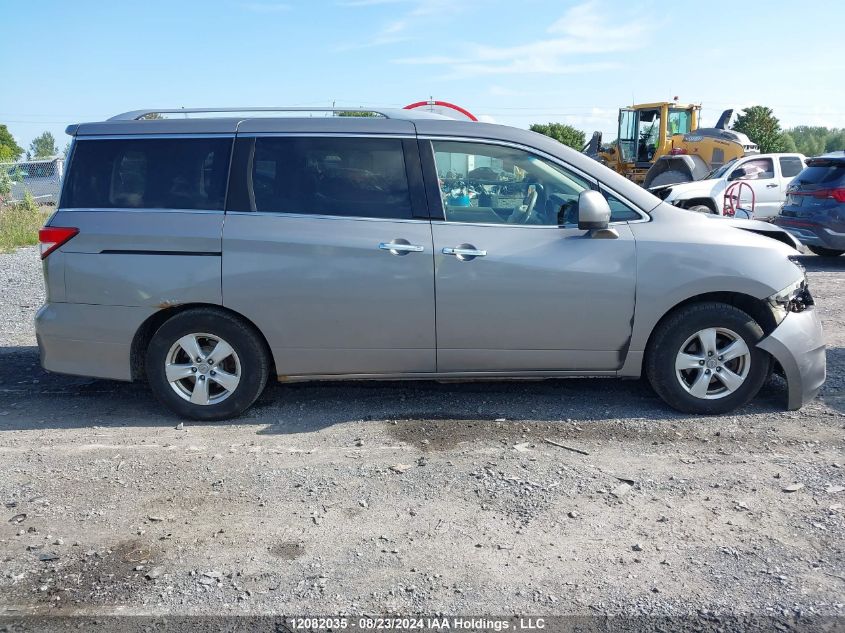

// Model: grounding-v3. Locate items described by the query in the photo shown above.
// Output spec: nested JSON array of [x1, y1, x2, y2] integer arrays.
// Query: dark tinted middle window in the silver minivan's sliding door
[[234, 137, 412, 219]]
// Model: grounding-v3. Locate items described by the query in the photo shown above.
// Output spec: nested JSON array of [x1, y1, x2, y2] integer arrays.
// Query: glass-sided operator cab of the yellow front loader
[[618, 102, 700, 169]]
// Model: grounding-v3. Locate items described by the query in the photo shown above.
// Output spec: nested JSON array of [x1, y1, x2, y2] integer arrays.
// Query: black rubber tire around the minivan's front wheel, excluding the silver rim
[[645, 302, 772, 415]]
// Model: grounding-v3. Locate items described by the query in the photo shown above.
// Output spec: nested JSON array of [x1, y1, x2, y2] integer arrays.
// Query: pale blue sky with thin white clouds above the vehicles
[[0, 0, 845, 149]]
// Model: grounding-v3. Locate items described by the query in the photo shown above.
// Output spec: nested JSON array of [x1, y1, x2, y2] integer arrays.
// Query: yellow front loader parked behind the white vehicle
[[585, 100, 760, 188]]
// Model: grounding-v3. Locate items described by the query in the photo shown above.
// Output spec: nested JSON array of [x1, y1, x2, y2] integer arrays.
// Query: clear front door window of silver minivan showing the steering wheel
[[432, 141, 591, 226]]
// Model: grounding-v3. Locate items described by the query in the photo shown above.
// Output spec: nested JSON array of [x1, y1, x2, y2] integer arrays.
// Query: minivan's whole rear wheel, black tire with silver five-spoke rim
[[146, 308, 270, 421]]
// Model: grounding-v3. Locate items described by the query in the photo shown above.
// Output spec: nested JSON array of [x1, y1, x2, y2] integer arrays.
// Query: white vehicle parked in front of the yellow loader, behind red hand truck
[[649, 154, 806, 220]]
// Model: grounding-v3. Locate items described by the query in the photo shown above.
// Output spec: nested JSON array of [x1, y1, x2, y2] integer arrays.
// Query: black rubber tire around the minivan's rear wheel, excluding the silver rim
[[146, 308, 270, 421]]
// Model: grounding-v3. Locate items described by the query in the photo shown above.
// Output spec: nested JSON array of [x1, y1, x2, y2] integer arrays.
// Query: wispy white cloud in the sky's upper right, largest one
[[396, 2, 653, 77]]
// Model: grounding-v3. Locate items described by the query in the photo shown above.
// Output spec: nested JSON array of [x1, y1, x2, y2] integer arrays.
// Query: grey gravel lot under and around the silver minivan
[[0, 244, 845, 623]]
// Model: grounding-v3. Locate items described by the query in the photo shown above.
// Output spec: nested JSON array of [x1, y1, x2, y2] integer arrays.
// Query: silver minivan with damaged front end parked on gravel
[[36, 109, 825, 420]]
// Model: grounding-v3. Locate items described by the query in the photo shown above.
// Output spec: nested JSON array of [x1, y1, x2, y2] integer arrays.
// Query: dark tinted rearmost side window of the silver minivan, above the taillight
[[61, 138, 232, 211]]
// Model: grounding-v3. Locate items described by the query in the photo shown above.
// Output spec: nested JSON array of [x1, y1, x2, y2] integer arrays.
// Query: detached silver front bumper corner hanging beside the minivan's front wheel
[[757, 307, 826, 411]]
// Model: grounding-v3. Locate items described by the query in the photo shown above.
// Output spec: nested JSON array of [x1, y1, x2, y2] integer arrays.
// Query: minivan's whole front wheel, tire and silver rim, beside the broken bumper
[[645, 303, 772, 415]]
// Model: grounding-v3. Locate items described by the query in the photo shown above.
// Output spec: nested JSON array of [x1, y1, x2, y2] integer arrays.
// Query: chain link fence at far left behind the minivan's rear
[[0, 156, 65, 206]]
